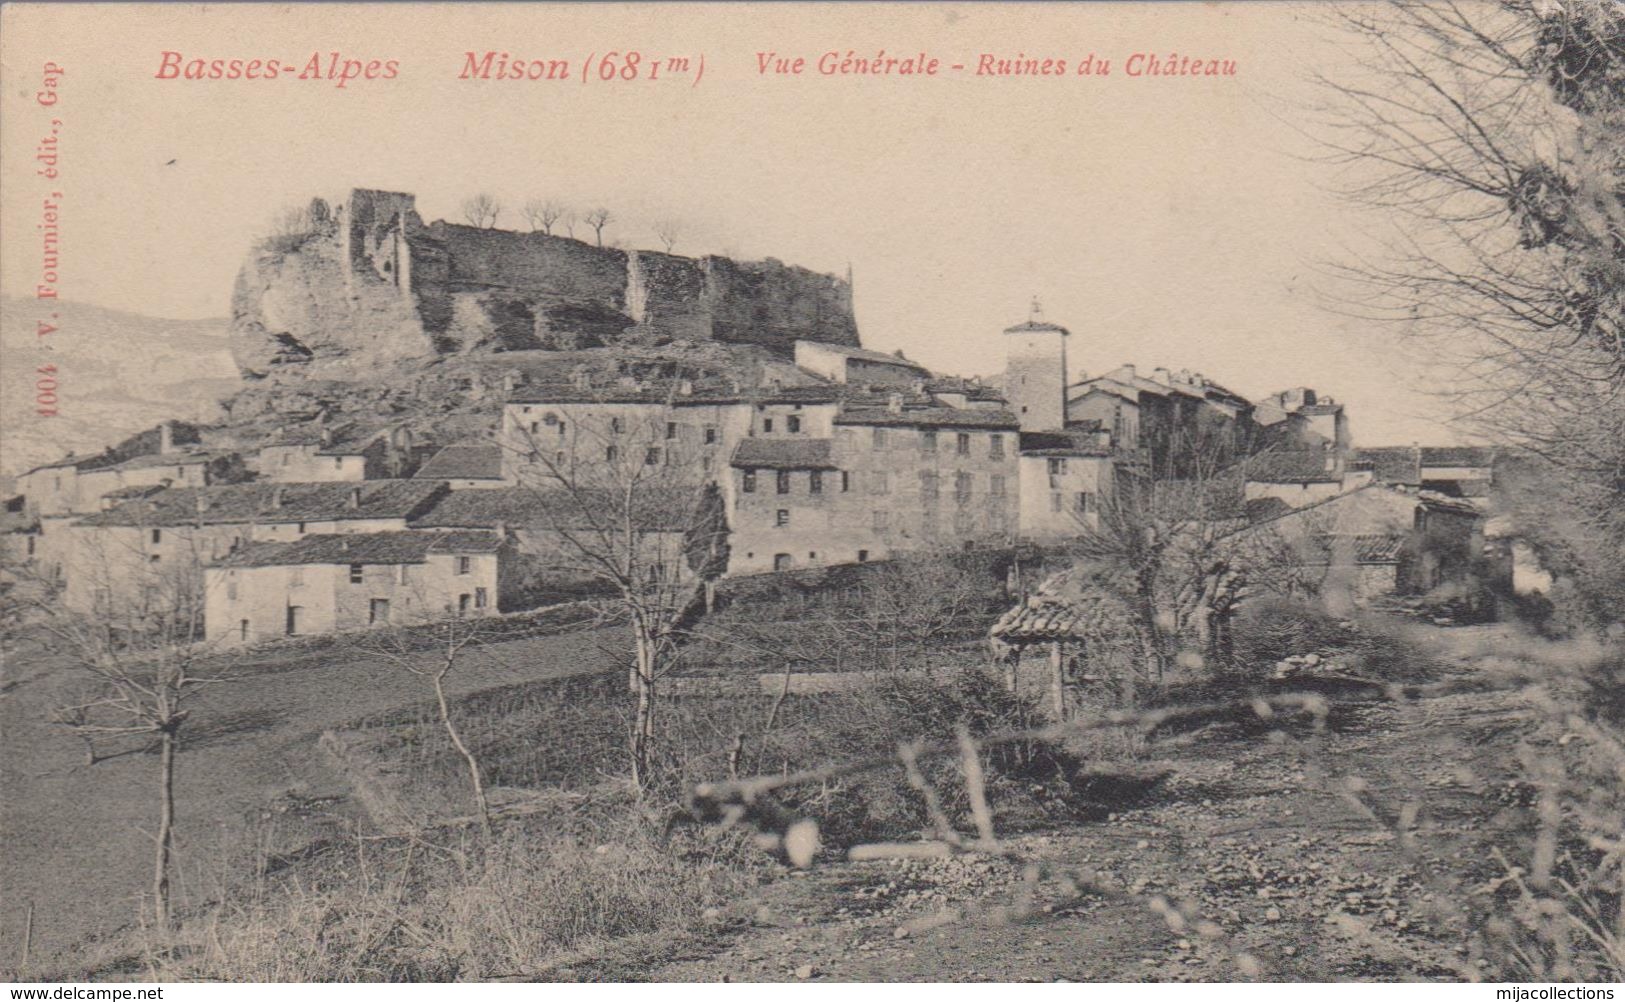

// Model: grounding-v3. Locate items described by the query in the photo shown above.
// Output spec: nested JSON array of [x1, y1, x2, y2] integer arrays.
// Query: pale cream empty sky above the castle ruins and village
[[0, 3, 1456, 445]]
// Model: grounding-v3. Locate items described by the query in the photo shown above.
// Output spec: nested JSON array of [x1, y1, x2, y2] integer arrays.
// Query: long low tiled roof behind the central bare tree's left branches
[[408, 487, 699, 533]]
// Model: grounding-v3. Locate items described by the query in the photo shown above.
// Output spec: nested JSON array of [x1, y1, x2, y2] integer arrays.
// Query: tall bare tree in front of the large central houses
[[502, 401, 728, 786]]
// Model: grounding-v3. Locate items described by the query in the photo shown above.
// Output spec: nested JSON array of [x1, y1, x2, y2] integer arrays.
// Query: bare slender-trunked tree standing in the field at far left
[[9, 542, 234, 929]]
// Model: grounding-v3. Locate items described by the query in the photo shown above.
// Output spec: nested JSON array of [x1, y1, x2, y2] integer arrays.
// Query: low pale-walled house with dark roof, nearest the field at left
[[203, 531, 501, 646]]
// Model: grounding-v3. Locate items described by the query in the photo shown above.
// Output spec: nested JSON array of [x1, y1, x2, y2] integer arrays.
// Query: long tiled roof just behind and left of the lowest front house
[[76, 481, 445, 526]]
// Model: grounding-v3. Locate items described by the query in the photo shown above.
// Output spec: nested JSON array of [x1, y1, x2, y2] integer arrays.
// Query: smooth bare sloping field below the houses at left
[[0, 630, 624, 970]]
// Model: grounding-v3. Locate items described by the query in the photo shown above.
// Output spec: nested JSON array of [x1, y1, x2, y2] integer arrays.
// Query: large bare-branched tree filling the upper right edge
[[1318, 0, 1625, 623]]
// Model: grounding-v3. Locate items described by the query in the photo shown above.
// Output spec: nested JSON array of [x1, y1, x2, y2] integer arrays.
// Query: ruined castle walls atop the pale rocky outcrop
[[232, 190, 858, 378]]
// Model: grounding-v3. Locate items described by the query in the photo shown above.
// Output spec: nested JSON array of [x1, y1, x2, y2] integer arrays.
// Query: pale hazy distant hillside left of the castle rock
[[0, 297, 241, 474]]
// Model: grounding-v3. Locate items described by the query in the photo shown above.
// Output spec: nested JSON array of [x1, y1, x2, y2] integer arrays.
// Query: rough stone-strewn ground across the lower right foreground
[[647, 630, 1529, 981]]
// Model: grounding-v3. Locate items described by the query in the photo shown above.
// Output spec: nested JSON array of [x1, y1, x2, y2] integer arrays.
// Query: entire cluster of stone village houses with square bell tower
[[5, 258, 1521, 645]]
